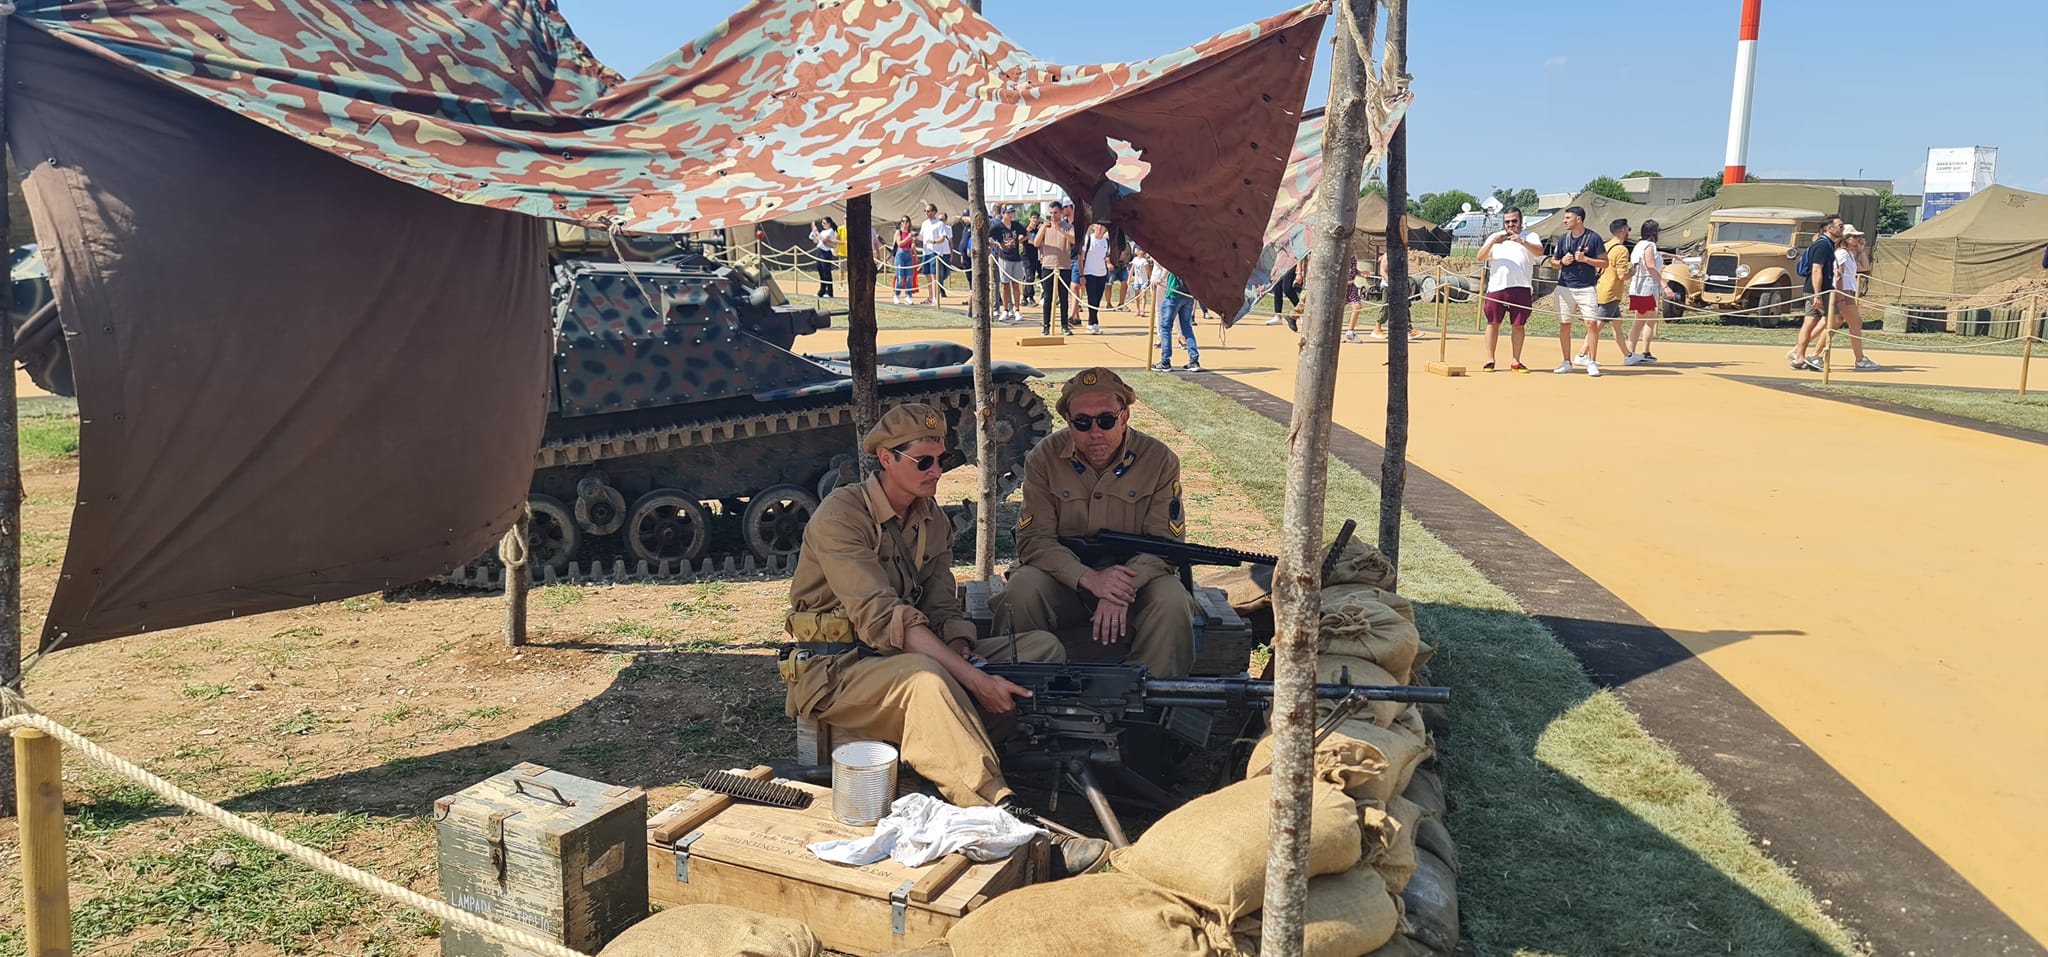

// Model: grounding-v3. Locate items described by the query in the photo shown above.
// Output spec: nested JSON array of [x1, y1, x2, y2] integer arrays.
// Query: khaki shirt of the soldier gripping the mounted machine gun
[[788, 475, 975, 654]]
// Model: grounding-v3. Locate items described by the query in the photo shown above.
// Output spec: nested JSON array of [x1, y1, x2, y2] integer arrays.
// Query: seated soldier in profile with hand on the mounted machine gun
[[780, 404, 1108, 871]]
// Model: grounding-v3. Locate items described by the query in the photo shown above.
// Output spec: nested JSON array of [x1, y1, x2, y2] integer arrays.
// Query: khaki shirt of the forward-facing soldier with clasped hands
[[1018, 428, 1188, 588]]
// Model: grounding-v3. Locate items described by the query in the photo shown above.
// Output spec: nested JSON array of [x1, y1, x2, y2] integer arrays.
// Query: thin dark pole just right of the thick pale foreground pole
[[1380, 0, 1409, 576]]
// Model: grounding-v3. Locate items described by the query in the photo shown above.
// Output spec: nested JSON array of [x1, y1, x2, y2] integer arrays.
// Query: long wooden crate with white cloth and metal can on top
[[647, 768, 1051, 955]]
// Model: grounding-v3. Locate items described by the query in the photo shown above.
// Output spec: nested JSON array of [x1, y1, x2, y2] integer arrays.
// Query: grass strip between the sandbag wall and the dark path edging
[[1133, 373, 1855, 955]]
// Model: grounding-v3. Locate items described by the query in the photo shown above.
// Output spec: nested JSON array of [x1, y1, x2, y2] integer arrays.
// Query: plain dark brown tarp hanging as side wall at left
[[6, 29, 549, 648]]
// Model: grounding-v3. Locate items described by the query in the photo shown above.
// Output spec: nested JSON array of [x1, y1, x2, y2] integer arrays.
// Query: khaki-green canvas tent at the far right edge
[[1866, 184, 2048, 301]]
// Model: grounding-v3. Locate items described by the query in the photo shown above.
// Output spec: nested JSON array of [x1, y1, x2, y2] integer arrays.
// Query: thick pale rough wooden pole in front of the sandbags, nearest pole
[[1260, 0, 1374, 957]]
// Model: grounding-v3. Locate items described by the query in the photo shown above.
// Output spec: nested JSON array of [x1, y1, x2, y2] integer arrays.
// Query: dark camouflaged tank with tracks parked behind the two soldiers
[[455, 252, 1051, 586]]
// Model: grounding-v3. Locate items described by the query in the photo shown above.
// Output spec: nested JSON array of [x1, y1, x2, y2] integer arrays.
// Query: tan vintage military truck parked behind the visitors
[[1665, 182, 1878, 328]]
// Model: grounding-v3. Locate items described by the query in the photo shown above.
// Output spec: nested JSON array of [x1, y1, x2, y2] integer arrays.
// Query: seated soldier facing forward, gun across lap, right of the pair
[[991, 369, 1196, 678]]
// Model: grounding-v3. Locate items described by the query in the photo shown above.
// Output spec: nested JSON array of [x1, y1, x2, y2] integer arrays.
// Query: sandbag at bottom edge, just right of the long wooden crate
[[946, 877, 1220, 957]]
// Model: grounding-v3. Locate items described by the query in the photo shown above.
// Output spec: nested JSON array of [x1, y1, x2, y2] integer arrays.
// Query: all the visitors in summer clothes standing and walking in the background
[[811, 201, 1880, 377]]
